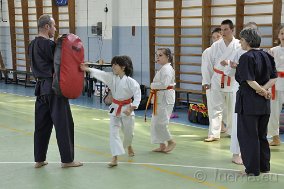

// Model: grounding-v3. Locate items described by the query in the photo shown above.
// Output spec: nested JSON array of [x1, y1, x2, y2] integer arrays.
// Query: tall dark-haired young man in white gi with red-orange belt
[[204, 20, 240, 142]]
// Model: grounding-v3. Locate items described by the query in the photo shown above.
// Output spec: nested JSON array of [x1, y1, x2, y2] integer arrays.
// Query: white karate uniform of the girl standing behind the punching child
[[151, 63, 175, 144]]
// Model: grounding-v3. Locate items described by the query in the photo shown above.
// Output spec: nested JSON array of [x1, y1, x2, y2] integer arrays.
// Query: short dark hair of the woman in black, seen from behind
[[240, 28, 261, 48]]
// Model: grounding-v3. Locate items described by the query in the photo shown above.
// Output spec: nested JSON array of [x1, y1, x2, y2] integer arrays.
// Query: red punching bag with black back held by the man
[[52, 34, 84, 99]]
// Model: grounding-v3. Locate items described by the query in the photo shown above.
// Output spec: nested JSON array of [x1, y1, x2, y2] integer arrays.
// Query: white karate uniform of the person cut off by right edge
[[268, 46, 284, 136]]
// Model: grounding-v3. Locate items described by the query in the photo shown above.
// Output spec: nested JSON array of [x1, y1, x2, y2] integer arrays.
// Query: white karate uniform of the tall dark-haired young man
[[205, 38, 241, 138]]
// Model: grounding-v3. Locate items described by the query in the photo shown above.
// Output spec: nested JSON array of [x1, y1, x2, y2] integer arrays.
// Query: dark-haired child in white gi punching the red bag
[[81, 56, 141, 167]]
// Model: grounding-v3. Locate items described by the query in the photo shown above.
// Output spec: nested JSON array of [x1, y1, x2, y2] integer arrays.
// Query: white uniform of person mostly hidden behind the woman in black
[[224, 48, 246, 154]]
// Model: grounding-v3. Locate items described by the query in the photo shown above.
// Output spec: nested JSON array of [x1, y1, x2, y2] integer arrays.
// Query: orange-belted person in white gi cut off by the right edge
[[268, 25, 284, 146]]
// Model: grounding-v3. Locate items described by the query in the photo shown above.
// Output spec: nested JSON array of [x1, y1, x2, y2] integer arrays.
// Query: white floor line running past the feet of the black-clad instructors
[[0, 161, 284, 176]]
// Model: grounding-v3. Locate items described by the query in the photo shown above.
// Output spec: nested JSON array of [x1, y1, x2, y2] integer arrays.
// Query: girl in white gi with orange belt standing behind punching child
[[150, 48, 176, 152]]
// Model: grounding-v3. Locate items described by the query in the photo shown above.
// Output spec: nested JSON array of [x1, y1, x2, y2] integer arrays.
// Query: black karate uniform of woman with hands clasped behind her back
[[235, 49, 277, 176]]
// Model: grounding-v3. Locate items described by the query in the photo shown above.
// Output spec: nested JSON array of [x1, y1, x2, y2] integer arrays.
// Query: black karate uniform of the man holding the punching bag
[[29, 37, 74, 163]]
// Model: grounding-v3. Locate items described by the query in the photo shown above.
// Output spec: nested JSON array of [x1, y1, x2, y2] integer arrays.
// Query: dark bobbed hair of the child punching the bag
[[111, 55, 133, 77]]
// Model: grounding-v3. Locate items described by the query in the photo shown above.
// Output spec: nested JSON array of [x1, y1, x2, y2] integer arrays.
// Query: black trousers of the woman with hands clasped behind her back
[[238, 114, 270, 176]]
